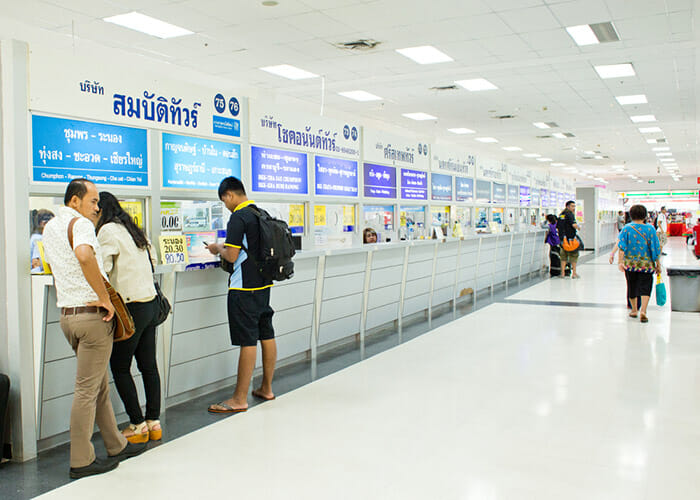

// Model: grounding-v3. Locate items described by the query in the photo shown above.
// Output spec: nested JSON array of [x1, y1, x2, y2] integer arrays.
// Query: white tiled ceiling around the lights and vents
[[0, 0, 700, 190]]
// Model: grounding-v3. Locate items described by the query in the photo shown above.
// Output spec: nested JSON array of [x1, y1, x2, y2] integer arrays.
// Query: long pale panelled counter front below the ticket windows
[[32, 230, 547, 449]]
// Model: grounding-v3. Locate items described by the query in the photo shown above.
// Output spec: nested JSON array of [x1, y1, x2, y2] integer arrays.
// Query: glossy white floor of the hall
[[34, 240, 700, 500]]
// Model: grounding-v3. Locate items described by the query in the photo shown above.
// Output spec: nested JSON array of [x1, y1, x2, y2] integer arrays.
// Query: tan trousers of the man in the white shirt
[[61, 312, 126, 467]]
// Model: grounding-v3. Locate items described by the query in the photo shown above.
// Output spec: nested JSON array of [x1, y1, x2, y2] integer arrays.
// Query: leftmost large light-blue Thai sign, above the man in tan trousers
[[32, 115, 148, 186]]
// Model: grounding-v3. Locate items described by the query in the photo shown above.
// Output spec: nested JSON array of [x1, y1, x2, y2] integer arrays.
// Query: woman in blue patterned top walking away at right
[[617, 205, 661, 323]]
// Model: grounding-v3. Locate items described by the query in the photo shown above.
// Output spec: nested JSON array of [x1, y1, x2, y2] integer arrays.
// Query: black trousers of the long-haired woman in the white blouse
[[109, 299, 160, 424]]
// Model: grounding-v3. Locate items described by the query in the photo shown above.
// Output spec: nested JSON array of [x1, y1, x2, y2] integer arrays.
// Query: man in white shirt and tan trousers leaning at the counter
[[43, 179, 146, 479]]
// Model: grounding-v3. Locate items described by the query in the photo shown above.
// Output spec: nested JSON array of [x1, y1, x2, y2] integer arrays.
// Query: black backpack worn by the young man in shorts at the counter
[[221, 206, 296, 281]]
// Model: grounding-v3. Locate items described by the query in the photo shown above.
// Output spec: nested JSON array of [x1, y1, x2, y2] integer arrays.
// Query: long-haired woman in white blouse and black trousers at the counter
[[97, 192, 163, 443]]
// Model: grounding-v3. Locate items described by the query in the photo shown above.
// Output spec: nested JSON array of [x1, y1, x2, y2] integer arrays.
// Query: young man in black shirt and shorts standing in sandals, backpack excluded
[[207, 177, 284, 414]]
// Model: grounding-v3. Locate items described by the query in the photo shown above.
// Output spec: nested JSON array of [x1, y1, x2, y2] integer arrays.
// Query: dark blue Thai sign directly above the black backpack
[[250, 146, 309, 194]]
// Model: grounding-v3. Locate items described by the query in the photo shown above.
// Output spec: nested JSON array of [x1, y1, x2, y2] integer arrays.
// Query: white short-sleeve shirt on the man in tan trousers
[[43, 207, 105, 307]]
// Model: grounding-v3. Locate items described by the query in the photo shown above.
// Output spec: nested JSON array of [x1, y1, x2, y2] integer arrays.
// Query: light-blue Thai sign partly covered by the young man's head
[[163, 132, 241, 189]]
